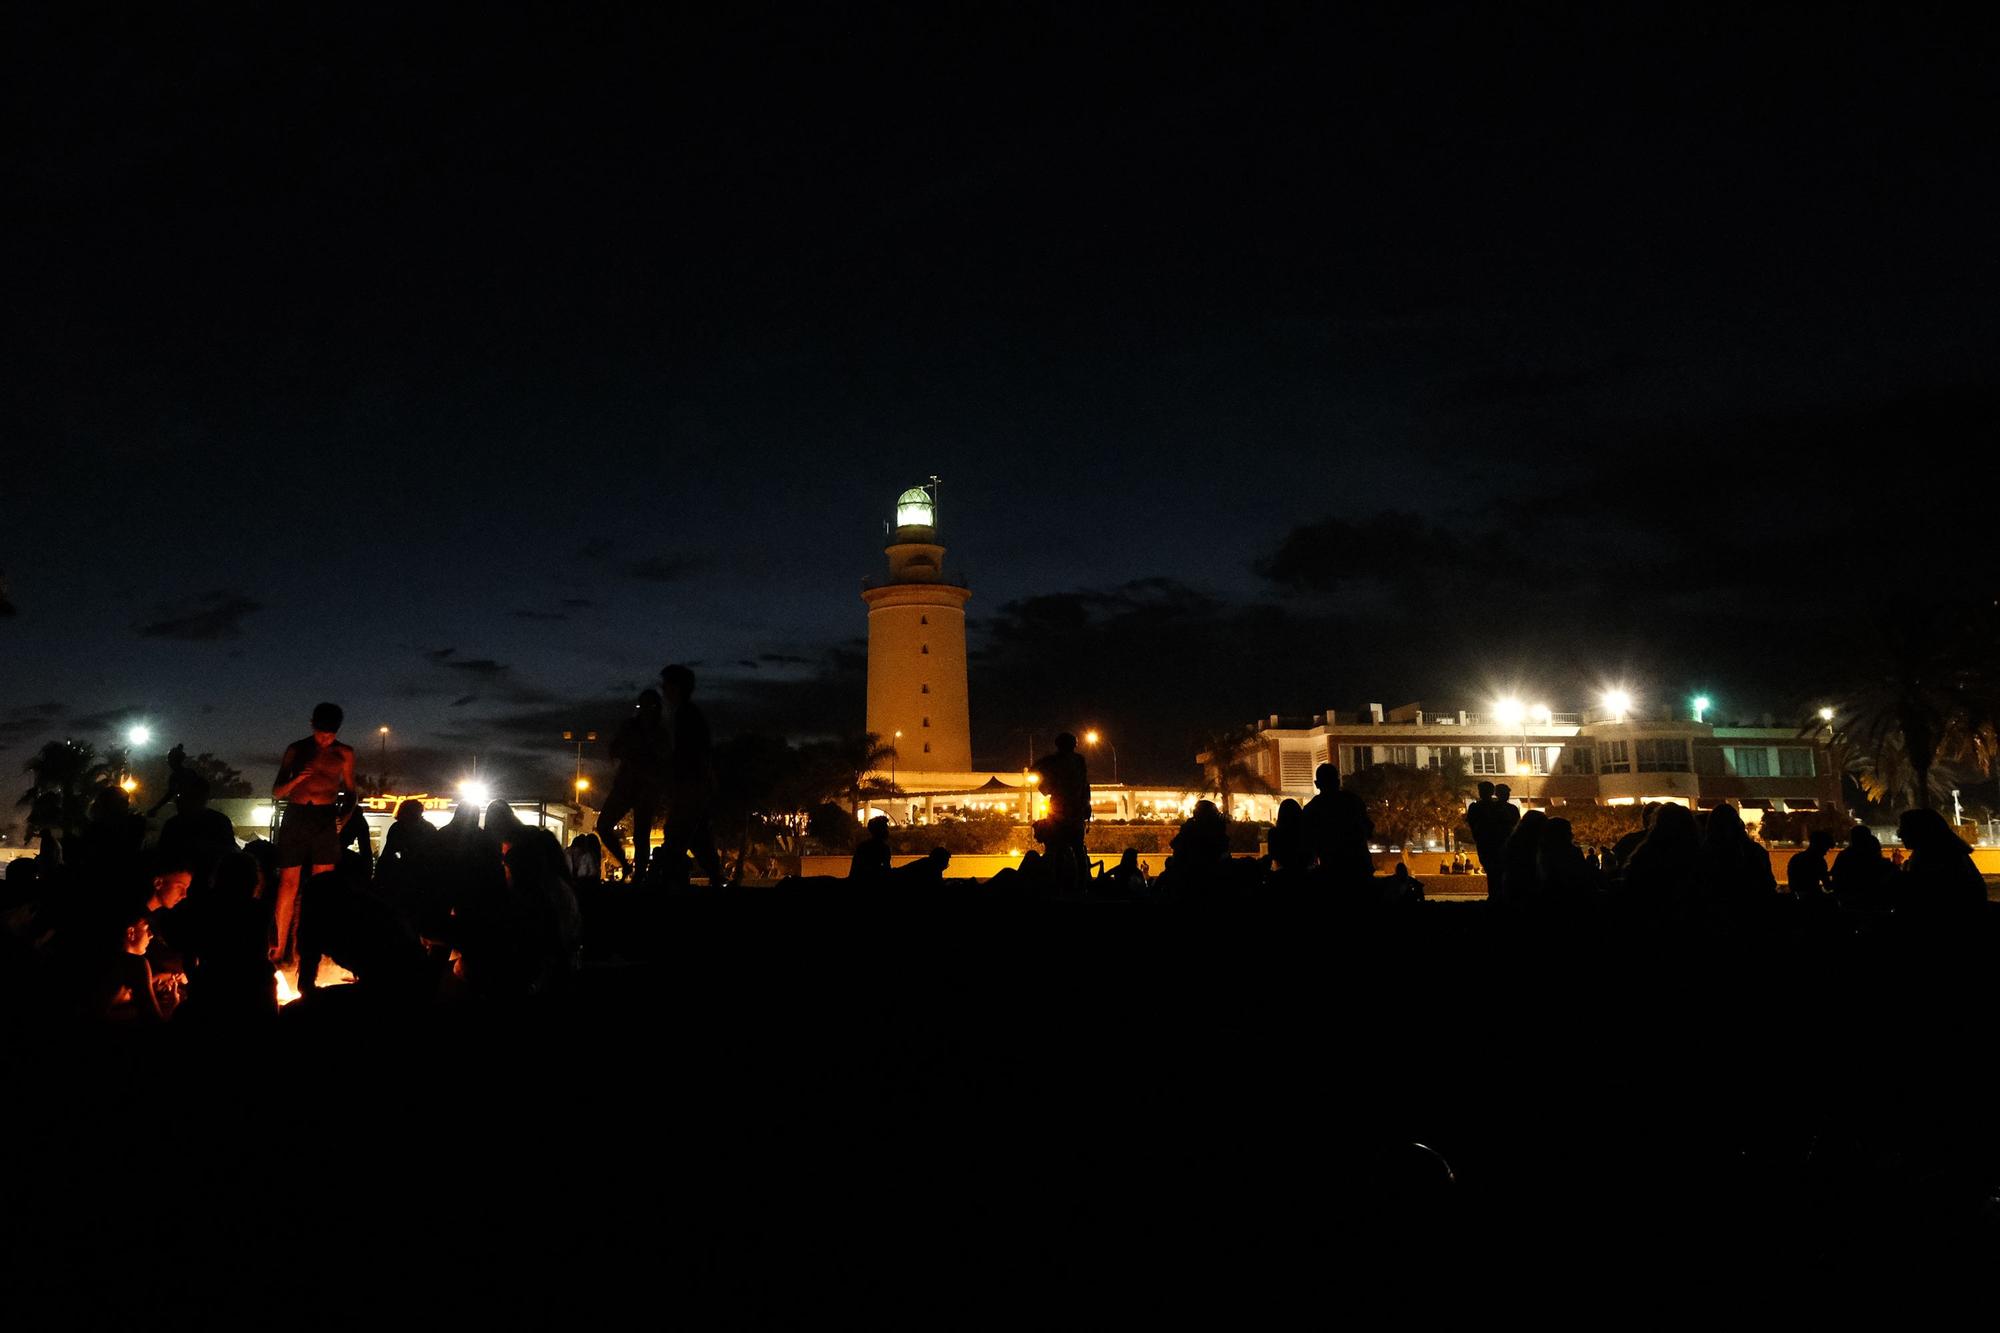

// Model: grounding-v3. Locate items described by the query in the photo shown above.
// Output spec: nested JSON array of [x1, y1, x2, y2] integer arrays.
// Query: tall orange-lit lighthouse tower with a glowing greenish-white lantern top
[[862, 478, 972, 775]]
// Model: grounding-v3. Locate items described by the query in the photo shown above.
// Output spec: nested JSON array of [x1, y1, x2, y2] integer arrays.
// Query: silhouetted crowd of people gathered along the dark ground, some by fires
[[0, 704, 1986, 1025]]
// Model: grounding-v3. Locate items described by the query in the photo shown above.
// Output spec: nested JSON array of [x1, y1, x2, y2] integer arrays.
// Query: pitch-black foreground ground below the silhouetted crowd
[[4, 895, 2000, 1329]]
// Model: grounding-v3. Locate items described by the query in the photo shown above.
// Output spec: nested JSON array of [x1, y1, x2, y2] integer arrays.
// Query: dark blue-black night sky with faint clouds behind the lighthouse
[[0, 4, 2000, 789]]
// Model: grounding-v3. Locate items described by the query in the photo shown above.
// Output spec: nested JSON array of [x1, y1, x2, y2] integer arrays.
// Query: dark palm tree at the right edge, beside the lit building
[[1832, 606, 2000, 811]]
